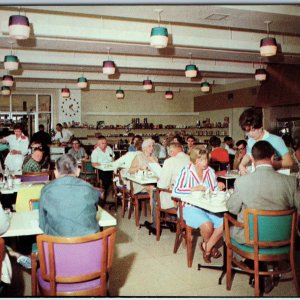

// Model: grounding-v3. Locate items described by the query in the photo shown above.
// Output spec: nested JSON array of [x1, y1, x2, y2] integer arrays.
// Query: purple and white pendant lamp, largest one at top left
[[8, 15, 30, 40]]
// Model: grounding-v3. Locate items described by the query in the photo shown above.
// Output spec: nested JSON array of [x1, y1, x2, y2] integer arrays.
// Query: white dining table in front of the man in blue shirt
[[1, 207, 117, 237]]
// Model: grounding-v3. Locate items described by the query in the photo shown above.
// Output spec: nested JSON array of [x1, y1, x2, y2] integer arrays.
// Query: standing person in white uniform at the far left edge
[[0, 124, 29, 175]]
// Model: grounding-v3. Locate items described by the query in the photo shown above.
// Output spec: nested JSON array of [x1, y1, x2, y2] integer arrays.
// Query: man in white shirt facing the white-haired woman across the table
[[145, 142, 190, 233]]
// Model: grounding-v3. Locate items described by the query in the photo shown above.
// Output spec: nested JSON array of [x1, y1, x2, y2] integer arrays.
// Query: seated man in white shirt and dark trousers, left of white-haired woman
[[91, 135, 115, 205]]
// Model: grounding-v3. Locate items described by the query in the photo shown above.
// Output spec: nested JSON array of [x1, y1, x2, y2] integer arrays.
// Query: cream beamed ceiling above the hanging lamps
[[0, 5, 300, 93]]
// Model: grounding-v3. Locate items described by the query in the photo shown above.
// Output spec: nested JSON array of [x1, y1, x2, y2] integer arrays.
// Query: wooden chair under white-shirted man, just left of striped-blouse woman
[[156, 188, 177, 241]]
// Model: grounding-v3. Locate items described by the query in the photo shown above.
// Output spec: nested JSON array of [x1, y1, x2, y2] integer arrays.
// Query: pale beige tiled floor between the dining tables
[[5, 205, 296, 297]]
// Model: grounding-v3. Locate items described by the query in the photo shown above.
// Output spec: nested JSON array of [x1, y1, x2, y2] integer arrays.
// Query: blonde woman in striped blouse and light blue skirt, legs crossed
[[172, 146, 224, 263]]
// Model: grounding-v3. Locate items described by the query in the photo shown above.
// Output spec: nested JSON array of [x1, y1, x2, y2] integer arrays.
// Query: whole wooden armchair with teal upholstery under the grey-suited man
[[224, 208, 299, 297]]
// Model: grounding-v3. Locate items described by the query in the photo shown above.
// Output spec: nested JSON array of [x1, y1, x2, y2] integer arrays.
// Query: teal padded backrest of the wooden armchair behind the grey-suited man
[[244, 208, 296, 247]]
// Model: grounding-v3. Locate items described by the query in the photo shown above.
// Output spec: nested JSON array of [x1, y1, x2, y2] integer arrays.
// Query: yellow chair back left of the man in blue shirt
[[16, 184, 44, 212]]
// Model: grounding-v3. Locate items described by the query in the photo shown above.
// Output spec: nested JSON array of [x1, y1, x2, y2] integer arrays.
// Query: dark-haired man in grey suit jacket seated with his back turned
[[227, 141, 300, 292]]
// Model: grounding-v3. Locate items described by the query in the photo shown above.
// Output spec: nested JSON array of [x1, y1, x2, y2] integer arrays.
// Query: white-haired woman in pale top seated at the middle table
[[128, 139, 158, 223]]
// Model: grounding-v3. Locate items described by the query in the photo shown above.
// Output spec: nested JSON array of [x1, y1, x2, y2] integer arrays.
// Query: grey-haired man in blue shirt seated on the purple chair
[[39, 154, 99, 237]]
